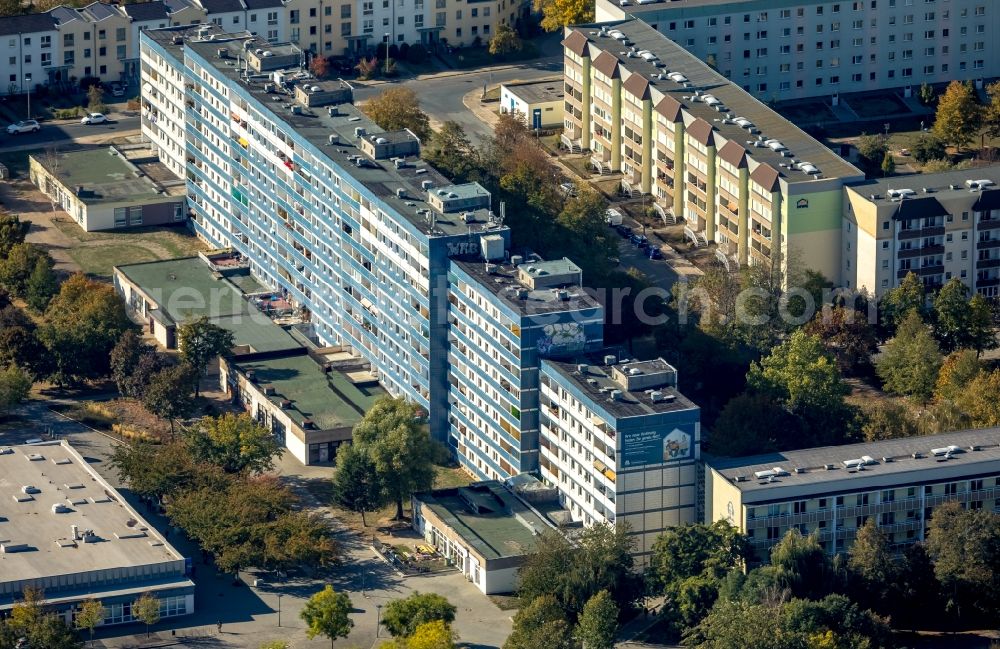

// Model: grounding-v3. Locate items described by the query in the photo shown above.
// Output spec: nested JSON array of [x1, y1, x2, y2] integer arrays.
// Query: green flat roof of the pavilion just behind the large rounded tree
[[235, 355, 385, 430]]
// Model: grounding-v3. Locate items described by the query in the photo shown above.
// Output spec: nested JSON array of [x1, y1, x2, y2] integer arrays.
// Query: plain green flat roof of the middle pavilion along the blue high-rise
[[117, 257, 300, 352]]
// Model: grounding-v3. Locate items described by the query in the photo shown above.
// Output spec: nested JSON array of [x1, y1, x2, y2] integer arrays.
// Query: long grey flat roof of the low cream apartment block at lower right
[[706, 428, 1000, 497]]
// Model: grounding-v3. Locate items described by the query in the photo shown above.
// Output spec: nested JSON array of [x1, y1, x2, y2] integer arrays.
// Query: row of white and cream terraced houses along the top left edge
[[0, 0, 530, 93]]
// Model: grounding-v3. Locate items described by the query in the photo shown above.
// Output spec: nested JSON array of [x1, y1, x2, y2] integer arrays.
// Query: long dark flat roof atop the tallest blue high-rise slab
[[144, 25, 507, 236]]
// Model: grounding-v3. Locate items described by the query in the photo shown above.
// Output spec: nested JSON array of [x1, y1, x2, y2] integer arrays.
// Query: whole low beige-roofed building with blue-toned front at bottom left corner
[[0, 442, 195, 625]]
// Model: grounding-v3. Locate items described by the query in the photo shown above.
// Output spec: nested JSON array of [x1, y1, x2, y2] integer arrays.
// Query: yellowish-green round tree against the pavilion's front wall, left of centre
[[187, 412, 283, 474]]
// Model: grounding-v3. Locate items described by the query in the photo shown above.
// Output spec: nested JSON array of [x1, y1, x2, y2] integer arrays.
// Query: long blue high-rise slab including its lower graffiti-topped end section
[[141, 26, 616, 479]]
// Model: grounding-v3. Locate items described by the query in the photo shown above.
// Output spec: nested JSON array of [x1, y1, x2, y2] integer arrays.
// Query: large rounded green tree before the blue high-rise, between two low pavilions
[[353, 397, 440, 520]]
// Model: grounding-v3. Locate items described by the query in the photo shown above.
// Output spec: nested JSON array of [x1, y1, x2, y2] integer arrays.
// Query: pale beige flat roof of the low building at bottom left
[[0, 442, 190, 586]]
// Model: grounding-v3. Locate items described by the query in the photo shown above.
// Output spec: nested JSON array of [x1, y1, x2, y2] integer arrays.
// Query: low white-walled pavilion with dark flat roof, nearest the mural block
[[413, 480, 554, 595]]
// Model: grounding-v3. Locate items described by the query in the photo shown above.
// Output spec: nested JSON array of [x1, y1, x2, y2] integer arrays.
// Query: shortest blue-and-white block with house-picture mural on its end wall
[[539, 354, 701, 565]]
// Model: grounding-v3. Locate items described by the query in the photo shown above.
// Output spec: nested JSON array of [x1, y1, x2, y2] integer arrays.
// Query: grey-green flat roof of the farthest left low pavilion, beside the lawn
[[32, 148, 180, 205]]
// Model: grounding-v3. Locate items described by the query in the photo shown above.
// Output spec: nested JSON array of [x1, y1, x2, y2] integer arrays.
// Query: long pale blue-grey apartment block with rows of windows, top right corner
[[596, 0, 1000, 101]]
